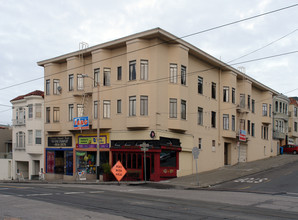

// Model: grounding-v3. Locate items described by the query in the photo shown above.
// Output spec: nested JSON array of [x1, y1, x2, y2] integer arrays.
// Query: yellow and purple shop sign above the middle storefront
[[77, 133, 110, 148]]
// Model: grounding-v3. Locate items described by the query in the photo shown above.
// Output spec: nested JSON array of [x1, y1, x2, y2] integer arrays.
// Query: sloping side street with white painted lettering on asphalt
[[213, 158, 298, 194]]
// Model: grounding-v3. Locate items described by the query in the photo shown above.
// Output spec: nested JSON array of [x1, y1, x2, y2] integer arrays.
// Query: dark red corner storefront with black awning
[[110, 137, 181, 181]]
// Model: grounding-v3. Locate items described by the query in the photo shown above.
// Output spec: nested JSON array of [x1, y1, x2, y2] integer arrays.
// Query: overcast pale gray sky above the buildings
[[0, 0, 298, 124]]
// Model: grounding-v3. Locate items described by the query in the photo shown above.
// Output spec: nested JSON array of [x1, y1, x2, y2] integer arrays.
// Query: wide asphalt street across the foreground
[[0, 183, 298, 220]]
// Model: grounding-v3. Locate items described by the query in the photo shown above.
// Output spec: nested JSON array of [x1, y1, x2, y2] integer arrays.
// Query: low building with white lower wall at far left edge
[[0, 125, 12, 180]]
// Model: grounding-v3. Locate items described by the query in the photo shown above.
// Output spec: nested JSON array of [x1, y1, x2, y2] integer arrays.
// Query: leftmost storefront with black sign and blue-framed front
[[45, 136, 73, 176]]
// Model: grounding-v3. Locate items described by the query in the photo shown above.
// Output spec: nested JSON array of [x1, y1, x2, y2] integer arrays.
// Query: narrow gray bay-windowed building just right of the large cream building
[[273, 94, 289, 146]]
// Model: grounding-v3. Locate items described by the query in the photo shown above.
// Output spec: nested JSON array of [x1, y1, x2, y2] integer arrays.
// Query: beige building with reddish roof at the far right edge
[[288, 97, 298, 145]]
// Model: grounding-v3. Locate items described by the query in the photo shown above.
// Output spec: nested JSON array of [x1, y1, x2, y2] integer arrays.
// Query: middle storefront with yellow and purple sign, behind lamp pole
[[75, 133, 110, 178]]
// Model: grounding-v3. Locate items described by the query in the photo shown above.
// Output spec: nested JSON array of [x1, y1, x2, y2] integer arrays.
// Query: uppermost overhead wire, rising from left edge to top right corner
[[0, 4, 298, 91]]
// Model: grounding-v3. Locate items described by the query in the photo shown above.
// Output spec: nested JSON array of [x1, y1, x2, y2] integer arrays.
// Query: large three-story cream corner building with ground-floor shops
[[38, 28, 278, 181]]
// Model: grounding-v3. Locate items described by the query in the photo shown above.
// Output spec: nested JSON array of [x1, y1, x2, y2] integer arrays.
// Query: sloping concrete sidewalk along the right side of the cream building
[[155, 154, 298, 189]]
